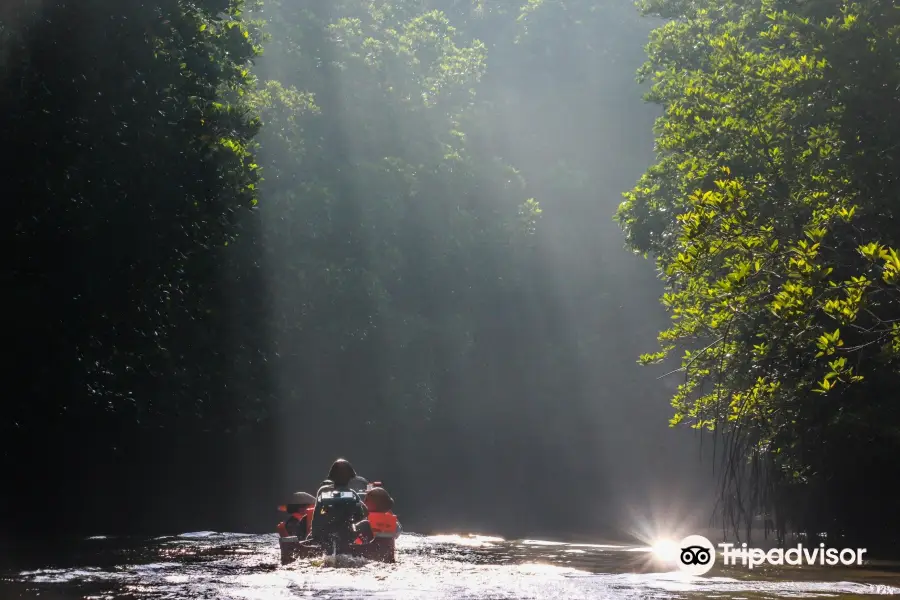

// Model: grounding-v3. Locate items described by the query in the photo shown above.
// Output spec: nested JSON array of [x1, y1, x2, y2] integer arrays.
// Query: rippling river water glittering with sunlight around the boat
[[0, 532, 900, 600]]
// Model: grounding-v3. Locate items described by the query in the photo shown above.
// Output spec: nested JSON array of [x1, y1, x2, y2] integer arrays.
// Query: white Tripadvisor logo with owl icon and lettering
[[677, 535, 866, 575]]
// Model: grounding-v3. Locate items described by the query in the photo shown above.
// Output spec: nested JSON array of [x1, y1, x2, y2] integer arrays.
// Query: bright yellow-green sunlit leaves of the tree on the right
[[616, 0, 900, 540]]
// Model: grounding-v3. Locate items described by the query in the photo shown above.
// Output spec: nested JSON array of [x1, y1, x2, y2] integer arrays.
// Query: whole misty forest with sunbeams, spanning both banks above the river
[[0, 0, 900, 552]]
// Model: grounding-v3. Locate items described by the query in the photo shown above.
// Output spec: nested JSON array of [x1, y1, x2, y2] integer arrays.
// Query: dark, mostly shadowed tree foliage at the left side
[[0, 0, 259, 432]]
